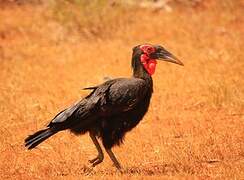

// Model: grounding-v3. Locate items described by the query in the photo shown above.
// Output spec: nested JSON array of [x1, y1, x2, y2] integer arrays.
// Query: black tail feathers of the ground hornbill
[[25, 128, 57, 149]]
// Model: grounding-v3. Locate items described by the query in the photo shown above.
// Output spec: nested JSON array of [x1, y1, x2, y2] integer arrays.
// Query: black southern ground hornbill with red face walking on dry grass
[[25, 44, 183, 169]]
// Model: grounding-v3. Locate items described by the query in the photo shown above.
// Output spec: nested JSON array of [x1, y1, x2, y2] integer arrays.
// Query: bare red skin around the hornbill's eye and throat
[[140, 45, 157, 76]]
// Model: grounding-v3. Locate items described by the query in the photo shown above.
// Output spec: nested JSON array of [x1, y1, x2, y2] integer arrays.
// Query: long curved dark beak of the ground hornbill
[[154, 46, 184, 66]]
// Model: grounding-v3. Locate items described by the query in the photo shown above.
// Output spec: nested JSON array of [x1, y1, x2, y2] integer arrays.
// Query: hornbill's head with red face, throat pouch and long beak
[[132, 44, 183, 76]]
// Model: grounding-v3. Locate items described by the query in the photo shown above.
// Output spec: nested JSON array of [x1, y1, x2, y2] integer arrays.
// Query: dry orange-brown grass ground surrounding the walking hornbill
[[0, 0, 244, 179]]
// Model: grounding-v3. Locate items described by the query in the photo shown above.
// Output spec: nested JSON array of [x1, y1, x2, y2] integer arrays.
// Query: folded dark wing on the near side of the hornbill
[[48, 78, 147, 129]]
